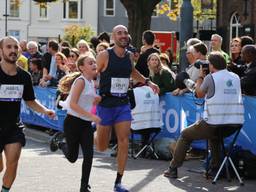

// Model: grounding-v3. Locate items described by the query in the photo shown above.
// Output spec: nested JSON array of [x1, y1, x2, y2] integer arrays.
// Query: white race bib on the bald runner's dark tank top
[[110, 78, 129, 97]]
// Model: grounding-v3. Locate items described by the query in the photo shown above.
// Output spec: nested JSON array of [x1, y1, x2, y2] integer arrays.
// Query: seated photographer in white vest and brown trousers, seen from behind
[[164, 52, 244, 178]]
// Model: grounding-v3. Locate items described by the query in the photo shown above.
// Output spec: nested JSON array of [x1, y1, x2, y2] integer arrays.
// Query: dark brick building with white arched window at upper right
[[217, 0, 256, 50]]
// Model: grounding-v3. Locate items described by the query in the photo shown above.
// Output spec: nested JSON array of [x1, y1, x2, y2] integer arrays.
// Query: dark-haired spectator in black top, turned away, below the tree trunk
[[135, 30, 160, 77]]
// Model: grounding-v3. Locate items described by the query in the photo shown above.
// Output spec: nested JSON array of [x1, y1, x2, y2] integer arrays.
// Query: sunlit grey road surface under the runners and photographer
[[0, 127, 256, 192]]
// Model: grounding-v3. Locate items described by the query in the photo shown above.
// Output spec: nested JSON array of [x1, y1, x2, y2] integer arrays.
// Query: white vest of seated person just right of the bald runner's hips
[[131, 86, 163, 130]]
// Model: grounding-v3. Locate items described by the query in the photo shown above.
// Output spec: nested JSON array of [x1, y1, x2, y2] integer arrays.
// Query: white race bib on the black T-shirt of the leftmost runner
[[0, 84, 24, 101]]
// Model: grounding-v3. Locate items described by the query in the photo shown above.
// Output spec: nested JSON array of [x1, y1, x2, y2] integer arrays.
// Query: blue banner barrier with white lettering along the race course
[[21, 87, 256, 154]]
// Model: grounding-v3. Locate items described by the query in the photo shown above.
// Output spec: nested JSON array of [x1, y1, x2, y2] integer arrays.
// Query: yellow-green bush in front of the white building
[[63, 25, 95, 46]]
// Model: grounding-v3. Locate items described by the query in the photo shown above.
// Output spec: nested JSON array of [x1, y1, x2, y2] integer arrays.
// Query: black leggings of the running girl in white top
[[61, 115, 93, 187]]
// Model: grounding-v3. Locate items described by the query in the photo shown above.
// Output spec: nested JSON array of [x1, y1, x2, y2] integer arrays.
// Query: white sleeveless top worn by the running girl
[[60, 75, 96, 121]]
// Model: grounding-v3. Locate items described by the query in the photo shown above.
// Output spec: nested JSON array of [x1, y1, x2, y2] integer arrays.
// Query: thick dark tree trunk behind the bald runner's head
[[120, 0, 161, 48]]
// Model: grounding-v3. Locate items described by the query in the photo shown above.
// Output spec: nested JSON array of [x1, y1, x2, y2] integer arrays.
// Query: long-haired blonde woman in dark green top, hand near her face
[[148, 53, 175, 96]]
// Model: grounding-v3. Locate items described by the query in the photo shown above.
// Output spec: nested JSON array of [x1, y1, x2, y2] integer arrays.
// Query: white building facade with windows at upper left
[[0, 0, 98, 42]]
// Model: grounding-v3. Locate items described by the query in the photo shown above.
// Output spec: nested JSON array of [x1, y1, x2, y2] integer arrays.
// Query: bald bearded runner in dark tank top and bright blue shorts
[[95, 25, 159, 192]]
